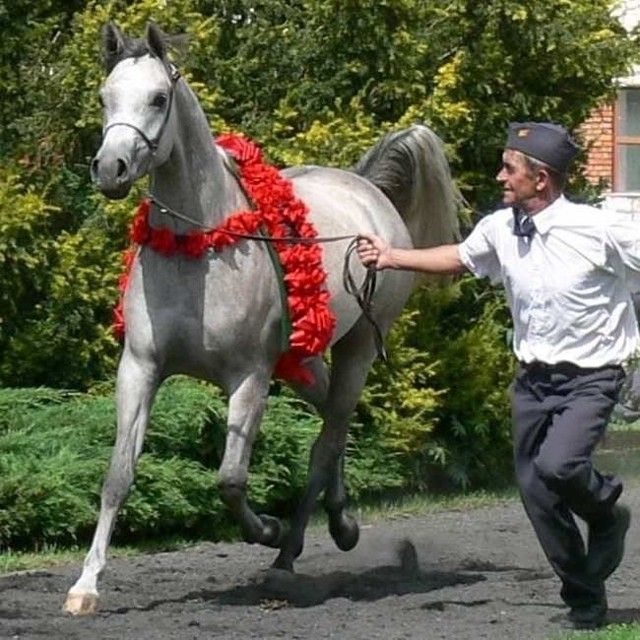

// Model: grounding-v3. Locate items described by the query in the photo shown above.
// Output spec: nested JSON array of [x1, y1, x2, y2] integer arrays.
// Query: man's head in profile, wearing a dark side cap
[[497, 122, 579, 213]]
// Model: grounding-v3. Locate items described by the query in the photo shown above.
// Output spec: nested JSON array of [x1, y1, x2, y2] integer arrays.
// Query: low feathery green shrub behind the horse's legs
[[0, 377, 416, 549]]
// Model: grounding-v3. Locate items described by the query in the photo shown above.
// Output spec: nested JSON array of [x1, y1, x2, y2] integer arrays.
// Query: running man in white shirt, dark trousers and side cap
[[358, 122, 640, 628]]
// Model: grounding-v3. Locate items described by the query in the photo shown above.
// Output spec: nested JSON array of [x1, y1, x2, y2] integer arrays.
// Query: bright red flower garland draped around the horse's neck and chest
[[114, 134, 336, 384]]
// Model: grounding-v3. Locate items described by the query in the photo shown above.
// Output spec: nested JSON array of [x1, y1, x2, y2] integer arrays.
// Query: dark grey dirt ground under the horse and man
[[0, 486, 640, 640]]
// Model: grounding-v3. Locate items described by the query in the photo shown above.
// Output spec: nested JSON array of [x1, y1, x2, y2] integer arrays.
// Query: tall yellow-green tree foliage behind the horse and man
[[0, 0, 638, 484]]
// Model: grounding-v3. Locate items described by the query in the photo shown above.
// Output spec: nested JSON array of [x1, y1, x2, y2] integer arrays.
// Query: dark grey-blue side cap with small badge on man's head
[[506, 122, 579, 174]]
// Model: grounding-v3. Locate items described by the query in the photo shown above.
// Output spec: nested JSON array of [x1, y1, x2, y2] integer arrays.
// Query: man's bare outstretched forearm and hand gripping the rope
[[358, 234, 468, 275]]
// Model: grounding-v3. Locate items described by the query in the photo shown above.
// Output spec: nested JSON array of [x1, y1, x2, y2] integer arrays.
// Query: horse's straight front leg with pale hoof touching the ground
[[64, 349, 158, 615]]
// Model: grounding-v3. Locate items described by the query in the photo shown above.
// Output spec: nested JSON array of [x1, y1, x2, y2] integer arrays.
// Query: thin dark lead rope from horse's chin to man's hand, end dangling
[[149, 196, 389, 364]]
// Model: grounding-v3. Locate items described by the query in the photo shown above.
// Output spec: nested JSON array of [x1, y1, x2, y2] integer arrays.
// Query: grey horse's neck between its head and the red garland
[[151, 81, 248, 233]]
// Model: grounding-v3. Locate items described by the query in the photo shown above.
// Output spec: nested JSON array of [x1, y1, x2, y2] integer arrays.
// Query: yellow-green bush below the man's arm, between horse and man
[[354, 277, 514, 491]]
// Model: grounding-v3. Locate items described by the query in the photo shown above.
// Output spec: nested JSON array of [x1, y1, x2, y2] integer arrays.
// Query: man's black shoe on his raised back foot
[[587, 505, 631, 581]]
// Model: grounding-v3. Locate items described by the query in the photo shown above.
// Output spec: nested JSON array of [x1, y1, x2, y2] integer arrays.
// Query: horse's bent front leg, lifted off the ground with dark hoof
[[218, 375, 284, 548]]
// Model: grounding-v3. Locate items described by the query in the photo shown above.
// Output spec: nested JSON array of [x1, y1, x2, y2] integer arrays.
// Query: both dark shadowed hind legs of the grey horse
[[273, 318, 376, 571]]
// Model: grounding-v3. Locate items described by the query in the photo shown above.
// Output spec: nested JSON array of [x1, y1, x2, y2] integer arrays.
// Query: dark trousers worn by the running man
[[512, 363, 624, 607]]
